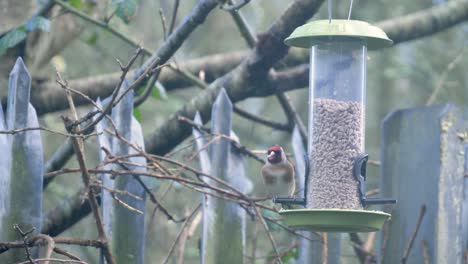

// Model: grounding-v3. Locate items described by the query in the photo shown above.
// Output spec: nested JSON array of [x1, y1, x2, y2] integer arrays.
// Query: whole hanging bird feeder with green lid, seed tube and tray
[[274, 20, 396, 232]]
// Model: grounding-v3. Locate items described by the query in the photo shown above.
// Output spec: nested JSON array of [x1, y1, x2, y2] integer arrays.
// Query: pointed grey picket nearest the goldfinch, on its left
[[198, 89, 244, 264]]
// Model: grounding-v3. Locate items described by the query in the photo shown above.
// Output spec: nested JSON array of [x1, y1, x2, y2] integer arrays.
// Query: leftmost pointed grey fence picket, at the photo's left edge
[[0, 58, 44, 263]]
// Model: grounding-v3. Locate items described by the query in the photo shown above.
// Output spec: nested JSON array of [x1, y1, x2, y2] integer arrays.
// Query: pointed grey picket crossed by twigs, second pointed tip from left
[[104, 87, 145, 264]]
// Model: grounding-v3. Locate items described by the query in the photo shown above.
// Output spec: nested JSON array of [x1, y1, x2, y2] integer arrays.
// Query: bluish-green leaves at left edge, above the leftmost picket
[[0, 16, 50, 55]]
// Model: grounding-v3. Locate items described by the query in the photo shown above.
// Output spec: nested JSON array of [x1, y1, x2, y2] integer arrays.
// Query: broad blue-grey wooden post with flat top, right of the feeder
[[378, 105, 468, 264]]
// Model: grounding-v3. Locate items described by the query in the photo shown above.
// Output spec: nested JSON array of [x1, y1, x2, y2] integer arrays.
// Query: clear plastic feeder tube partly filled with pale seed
[[307, 37, 367, 209]]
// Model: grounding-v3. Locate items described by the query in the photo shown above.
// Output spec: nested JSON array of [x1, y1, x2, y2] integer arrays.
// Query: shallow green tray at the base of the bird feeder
[[279, 209, 390, 232]]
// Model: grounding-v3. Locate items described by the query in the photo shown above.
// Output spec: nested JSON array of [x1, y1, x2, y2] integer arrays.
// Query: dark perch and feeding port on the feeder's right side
[[353, 153, 397, 207]]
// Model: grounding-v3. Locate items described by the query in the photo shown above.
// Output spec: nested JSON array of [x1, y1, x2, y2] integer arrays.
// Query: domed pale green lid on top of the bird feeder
[[284, 19, 393, 50]]
